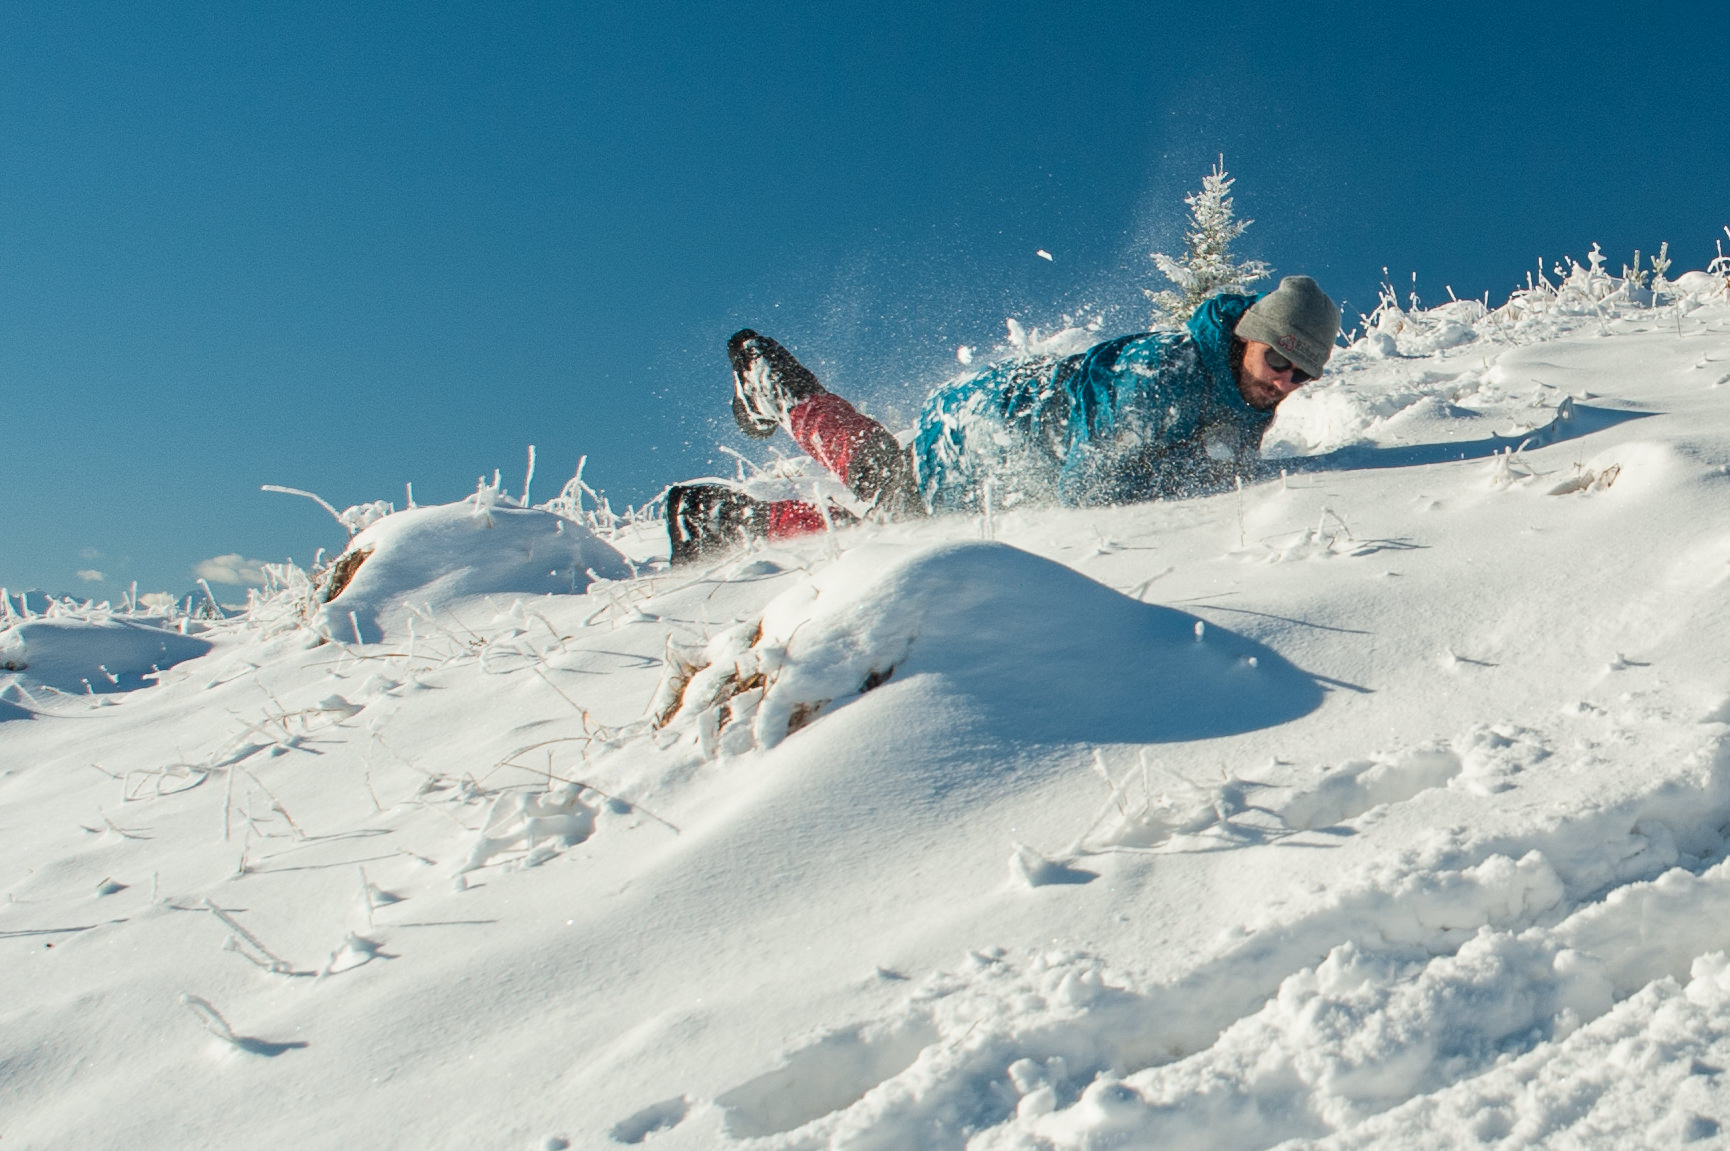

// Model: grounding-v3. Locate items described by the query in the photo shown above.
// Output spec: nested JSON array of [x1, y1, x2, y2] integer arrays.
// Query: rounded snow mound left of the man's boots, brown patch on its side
[[317, 500, 631, 642]]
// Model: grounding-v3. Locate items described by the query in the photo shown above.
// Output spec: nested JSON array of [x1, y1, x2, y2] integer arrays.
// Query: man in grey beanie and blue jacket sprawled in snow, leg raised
[[666, 275, 1339, 564]]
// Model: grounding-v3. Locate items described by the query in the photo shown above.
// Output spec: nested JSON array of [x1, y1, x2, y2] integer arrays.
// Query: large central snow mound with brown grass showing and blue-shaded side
[[657, 542, 1322, 753]]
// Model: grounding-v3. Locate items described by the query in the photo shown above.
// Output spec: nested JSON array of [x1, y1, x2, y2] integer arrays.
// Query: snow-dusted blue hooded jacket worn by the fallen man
[[912, 294, 1273, 511]]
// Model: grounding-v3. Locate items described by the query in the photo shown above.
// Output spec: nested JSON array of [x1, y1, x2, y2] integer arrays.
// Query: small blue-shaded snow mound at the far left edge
[[0, 616, 211, 696]]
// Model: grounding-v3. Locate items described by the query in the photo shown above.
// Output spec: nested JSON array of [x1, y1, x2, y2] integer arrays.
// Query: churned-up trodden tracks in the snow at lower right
[[647, 725, 1730, 1151]]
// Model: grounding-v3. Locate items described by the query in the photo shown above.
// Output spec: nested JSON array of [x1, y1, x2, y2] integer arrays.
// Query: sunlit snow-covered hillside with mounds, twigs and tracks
[[0, 272, 1730, 1151]]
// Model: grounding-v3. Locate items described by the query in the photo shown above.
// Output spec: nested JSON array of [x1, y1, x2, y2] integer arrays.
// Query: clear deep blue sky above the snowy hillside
[[0, 0, 1730, 597]]
